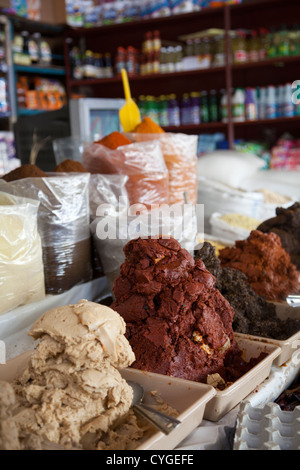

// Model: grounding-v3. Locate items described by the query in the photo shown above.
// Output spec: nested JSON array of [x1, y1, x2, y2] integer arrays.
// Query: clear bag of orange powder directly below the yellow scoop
[[126, 133, 198, 205]]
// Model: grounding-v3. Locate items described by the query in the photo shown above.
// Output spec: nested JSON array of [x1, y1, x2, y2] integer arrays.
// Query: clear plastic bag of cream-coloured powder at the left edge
[[0, 193, 45, 314]]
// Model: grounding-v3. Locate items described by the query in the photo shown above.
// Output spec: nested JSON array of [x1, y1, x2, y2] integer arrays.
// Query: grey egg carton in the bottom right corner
[[233, 402, 300, 450]]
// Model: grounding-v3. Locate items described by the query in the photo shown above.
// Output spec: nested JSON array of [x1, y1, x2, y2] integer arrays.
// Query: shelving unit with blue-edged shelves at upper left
[[0, 14, 70, 171]]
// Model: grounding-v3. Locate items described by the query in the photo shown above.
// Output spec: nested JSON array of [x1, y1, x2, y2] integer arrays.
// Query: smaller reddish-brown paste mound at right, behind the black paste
[[219, 230, 300, 302]]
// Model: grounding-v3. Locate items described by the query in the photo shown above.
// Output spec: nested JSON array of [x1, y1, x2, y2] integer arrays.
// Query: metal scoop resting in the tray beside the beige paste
[[127, 381, 181, 434]]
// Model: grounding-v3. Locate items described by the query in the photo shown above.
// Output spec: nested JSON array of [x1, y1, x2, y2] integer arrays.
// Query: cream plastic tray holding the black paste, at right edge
[[235, 302, 300, 367]]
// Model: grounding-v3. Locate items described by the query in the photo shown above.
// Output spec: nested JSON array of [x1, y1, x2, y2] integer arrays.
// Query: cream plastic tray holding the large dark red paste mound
[[204, 336, 281, 421]]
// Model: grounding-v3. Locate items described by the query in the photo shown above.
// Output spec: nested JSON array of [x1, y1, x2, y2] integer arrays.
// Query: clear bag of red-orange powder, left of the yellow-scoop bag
[[83, 141, 169, 208]]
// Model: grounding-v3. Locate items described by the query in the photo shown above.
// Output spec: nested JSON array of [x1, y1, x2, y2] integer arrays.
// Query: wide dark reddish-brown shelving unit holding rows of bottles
[[65, 0, 300, 148]]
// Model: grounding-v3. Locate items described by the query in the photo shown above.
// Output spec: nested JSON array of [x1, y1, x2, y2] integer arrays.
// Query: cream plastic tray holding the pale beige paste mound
[[0, 351, 216, 450]]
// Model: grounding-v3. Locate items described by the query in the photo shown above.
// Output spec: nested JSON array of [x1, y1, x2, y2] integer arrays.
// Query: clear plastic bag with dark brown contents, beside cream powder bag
[[0, 173, 93, 295]]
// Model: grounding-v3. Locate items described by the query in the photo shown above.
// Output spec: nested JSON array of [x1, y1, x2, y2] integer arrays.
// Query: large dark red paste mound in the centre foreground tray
[[112, 239, 262, 382]]
